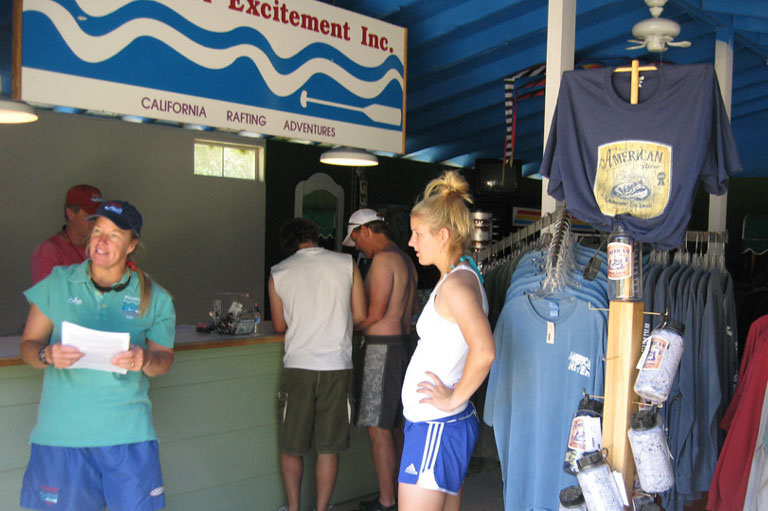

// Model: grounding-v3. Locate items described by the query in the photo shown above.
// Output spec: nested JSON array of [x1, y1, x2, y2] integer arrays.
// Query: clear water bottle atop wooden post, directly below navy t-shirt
[[607, 223, 643, 302]]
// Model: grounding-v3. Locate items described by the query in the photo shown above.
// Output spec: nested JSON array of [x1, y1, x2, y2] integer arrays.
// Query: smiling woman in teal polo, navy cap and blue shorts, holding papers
[[20, 201, 176, 511]]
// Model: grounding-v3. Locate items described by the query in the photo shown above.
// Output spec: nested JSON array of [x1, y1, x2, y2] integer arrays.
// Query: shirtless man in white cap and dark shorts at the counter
[[344, 209, 418, 511]]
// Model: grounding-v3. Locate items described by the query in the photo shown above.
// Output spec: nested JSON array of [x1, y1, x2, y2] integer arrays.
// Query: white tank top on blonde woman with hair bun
[[401, 265, 488, 422]]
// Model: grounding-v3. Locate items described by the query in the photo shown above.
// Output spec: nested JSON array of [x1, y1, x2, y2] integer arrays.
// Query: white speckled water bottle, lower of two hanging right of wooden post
[[627, 407, 675, 493]]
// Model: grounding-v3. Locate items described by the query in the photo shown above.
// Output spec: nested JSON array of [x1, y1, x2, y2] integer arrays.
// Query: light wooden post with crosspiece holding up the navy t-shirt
[[603, 60, 656, 507]]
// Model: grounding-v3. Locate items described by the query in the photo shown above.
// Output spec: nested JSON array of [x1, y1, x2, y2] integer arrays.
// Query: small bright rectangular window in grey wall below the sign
[[195, 140, 264, 181]]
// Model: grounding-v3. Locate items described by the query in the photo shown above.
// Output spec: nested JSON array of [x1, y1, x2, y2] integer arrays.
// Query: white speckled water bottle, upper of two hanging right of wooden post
[[634, 320, 685, 404]]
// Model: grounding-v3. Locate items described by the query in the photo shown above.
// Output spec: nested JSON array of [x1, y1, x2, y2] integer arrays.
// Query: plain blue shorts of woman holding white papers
[[21, 440, 165, 511]]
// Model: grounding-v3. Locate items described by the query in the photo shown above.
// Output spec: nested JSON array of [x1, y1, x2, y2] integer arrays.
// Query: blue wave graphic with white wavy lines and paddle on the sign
[[22, 0, 403, 130]]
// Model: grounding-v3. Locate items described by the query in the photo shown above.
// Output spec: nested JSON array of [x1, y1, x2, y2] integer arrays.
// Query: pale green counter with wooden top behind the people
[[0, 325, 377, 511]]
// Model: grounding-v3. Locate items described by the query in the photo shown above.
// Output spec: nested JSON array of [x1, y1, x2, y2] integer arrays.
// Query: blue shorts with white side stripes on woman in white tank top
[[397, 402, 480, 495]]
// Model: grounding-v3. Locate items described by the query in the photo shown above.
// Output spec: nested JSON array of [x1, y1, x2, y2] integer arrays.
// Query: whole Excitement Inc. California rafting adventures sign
[[17, 0, 406, 153]]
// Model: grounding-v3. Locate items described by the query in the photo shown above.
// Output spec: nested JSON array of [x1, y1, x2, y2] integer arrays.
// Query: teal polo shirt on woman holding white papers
[[24, 260, 176, 447]]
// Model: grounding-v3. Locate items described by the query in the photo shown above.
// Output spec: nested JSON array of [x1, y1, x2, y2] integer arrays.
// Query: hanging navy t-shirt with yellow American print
[[539, 64, 741, 249]]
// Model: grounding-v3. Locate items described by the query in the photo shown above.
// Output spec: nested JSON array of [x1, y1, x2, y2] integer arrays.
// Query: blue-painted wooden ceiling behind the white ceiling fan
[[316, 0, 768, 176]]
